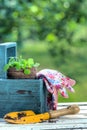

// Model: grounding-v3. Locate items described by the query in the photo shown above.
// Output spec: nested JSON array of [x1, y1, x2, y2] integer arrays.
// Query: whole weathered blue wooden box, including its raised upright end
[[0, 42, 48, 117]]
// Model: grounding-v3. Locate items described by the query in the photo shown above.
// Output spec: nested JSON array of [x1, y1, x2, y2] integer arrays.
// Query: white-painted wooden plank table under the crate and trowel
[[0, 102, 87, 130]]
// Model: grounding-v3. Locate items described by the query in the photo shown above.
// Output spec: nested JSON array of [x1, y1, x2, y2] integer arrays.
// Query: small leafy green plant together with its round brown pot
[[4, 56, 40, 79]]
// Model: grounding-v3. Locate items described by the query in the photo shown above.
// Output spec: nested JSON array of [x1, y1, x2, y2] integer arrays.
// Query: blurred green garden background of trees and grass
[[0, 0, 87, 102]]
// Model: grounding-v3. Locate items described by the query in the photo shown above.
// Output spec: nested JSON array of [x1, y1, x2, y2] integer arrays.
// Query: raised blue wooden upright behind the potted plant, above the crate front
[[0, 42, 17, 78]]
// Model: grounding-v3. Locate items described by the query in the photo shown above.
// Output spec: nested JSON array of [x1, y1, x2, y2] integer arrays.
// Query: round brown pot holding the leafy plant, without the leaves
[[7, 67, 37, 79]]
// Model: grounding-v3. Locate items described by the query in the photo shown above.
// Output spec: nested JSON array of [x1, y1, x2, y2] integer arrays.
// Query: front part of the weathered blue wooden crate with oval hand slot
[[0, 79, 47, 117]]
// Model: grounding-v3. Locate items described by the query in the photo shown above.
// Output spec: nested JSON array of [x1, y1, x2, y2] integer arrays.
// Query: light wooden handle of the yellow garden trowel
[[49, 105, 80, 119]]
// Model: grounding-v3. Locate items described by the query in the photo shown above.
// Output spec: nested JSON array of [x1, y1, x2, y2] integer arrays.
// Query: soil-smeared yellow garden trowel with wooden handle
[[4, 105, 80, 124]]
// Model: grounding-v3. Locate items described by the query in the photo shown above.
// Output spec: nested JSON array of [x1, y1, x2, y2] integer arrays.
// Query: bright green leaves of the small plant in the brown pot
[[4, 56, 40, 74]]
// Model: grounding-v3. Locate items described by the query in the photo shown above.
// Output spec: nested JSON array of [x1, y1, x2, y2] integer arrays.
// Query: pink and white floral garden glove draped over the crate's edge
[[37, 69, 76, 110]]
